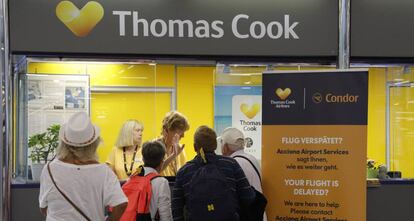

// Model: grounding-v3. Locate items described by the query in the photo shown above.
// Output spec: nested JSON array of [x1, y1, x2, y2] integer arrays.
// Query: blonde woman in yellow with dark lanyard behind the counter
[[106, 120, 144, 181]]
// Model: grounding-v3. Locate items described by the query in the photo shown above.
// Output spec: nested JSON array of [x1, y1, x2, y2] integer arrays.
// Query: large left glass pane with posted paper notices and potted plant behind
[[13, 59, 170, 183]]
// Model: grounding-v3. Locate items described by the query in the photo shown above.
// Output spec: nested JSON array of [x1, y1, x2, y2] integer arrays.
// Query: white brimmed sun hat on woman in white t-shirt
[[59, 112, 100, 147]]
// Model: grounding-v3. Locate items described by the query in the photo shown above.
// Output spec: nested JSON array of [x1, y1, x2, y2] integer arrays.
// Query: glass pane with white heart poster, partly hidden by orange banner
[[214, 63, 335, 161]]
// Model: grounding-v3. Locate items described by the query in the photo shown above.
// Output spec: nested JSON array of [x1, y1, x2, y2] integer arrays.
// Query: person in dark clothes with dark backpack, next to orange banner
[[172, 126, 255, 221]]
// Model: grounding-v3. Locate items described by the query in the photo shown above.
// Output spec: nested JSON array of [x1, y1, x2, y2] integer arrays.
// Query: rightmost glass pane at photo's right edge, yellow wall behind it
[[387, 66, 414, 178]]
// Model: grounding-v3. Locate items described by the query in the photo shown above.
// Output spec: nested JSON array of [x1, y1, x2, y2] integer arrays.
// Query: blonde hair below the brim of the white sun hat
[[56, 137, 101, 161]]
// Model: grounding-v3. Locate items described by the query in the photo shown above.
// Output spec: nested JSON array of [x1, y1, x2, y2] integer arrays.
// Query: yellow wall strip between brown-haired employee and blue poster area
[[177, 67, 215, 160]]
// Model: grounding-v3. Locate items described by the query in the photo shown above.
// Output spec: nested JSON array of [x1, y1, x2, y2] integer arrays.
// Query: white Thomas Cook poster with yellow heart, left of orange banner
[[231, 95, 262, 161]]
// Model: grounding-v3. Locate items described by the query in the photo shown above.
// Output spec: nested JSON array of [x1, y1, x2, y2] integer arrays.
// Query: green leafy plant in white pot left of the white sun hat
[[28, 124, 60, 163]]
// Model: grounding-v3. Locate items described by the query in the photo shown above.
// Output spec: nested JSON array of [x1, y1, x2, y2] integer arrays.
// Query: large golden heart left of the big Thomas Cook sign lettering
[[56, 1, 104, 37]]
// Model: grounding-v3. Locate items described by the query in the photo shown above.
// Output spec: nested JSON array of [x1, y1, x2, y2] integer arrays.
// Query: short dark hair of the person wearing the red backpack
[[142, 141, 165, 169]]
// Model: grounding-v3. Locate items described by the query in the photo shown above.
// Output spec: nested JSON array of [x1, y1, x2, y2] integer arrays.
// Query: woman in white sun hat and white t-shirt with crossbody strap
[[39, 112, 127, 221]]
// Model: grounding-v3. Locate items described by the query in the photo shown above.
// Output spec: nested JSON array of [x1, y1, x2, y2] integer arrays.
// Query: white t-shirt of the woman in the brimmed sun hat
[[39, 159, 128, 221]]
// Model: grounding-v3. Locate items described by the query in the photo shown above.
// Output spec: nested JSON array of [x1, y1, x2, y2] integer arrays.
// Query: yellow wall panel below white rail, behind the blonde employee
[[91, 92, 171, 162]]
